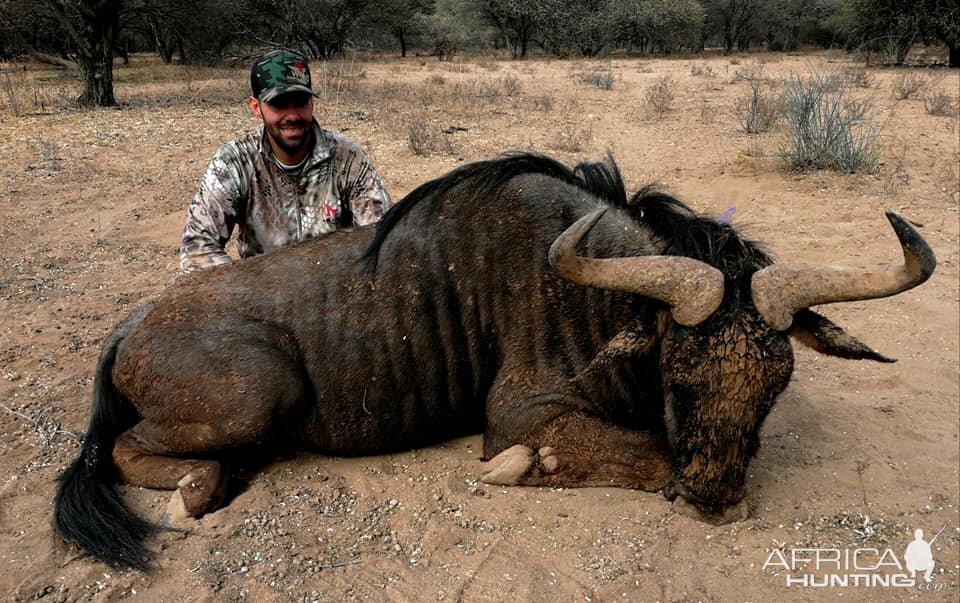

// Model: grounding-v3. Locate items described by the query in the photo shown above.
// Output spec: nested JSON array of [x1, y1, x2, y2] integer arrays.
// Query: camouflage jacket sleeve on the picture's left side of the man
[[178, 144, 246, 276]]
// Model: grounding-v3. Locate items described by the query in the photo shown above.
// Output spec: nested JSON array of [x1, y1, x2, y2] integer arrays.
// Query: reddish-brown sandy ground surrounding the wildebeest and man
[[0, 55, 960, 601]]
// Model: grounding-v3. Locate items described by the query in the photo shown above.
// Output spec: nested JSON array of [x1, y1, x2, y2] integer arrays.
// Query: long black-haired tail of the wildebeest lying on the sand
[[53, 306, 159, 570]]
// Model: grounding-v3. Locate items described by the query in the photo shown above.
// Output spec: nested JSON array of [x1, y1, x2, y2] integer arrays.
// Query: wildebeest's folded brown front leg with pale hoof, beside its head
[[481, 410, 673, 491]]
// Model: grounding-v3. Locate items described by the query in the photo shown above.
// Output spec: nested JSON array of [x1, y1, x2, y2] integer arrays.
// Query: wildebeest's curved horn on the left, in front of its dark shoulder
[[549, 208, 723, 326]]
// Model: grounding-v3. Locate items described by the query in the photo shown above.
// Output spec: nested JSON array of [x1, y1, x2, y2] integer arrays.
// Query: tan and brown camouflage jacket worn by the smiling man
[[179, 122, 393, 275]]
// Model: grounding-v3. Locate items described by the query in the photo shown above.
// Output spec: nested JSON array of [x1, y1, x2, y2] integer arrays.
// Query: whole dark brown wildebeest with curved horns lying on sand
[[54, 155, 936, 568]]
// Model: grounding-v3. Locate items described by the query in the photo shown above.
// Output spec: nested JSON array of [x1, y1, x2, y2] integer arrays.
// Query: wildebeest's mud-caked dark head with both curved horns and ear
[[551, 190, 936, 523]]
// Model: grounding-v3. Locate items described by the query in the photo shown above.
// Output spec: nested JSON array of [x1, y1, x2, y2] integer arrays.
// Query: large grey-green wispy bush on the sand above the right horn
[[781, 73, 880, 173]]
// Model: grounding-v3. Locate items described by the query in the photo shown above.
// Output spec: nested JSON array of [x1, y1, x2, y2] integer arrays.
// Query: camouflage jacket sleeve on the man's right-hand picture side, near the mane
[[336, 140, 393, 226]]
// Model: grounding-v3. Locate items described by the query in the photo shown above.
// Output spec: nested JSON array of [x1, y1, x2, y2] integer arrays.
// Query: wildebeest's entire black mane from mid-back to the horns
[[361, 153, 772, 278]]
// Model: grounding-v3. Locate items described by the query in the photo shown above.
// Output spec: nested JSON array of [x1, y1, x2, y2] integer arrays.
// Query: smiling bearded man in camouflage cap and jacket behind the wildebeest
[[179, 50, 393, 275]]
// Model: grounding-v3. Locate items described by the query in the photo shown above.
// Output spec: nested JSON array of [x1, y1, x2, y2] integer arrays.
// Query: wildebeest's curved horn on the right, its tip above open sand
[[752, 211, 937, 331]]
